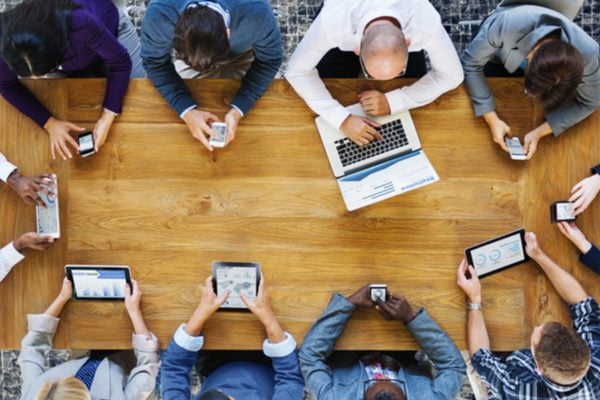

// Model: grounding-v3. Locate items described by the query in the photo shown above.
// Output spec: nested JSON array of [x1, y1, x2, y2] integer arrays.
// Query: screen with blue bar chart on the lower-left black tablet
[[71, 268, 127, 299]]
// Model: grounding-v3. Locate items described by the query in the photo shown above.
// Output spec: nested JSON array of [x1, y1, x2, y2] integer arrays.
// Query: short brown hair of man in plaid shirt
[[534, 322, 591, 385]]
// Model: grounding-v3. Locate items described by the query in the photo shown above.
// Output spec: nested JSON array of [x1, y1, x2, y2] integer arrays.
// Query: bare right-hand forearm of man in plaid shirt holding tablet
[[525, 232, 588, 305]]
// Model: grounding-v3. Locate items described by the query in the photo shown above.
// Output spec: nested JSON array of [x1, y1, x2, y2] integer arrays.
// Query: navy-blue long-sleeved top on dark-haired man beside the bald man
[[141, 0, 283, 115]]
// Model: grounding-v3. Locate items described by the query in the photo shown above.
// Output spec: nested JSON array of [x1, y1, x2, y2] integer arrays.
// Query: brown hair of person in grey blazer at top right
[[525, 40, 583, 113]]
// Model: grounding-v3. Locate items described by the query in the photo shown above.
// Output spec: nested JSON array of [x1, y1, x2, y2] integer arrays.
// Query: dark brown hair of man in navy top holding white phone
[[173, 6, 229, 72]]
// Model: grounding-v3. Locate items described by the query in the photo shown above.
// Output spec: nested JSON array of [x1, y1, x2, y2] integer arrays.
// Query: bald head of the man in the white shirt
[[360, 21, 408, 80]]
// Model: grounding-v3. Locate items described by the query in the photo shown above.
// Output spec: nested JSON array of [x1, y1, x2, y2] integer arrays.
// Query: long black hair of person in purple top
[[0, 0, 79, 77]]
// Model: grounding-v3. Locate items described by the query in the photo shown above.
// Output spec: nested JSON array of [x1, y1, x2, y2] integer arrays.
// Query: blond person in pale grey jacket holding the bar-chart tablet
[[18, 278, 160, 400]]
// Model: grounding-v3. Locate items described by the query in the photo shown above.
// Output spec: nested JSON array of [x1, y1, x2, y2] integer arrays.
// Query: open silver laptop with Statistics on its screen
[[315, 104, 440, 211]]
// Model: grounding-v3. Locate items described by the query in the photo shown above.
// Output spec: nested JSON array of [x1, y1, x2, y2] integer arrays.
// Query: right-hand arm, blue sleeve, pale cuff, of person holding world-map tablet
[[241, 274, 304, 400]]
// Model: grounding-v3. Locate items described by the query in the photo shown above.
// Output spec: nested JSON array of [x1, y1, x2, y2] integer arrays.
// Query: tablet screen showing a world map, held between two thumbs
[[215, 265, 259, 308]]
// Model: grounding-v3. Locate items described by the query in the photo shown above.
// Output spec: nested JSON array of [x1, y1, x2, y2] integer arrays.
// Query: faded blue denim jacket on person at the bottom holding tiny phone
[[298, 293, 466, 400]]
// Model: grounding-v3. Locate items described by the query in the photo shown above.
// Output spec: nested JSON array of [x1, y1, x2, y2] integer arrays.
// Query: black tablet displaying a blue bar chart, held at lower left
[[65, 265, 131, 300]]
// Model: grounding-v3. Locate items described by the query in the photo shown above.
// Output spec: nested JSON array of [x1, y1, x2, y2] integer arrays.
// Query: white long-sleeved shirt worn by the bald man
[[285, 0, 464, 127]]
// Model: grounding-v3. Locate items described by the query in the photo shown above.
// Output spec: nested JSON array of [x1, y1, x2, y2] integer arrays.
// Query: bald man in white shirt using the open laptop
[[285, 0, 463, 145]]
